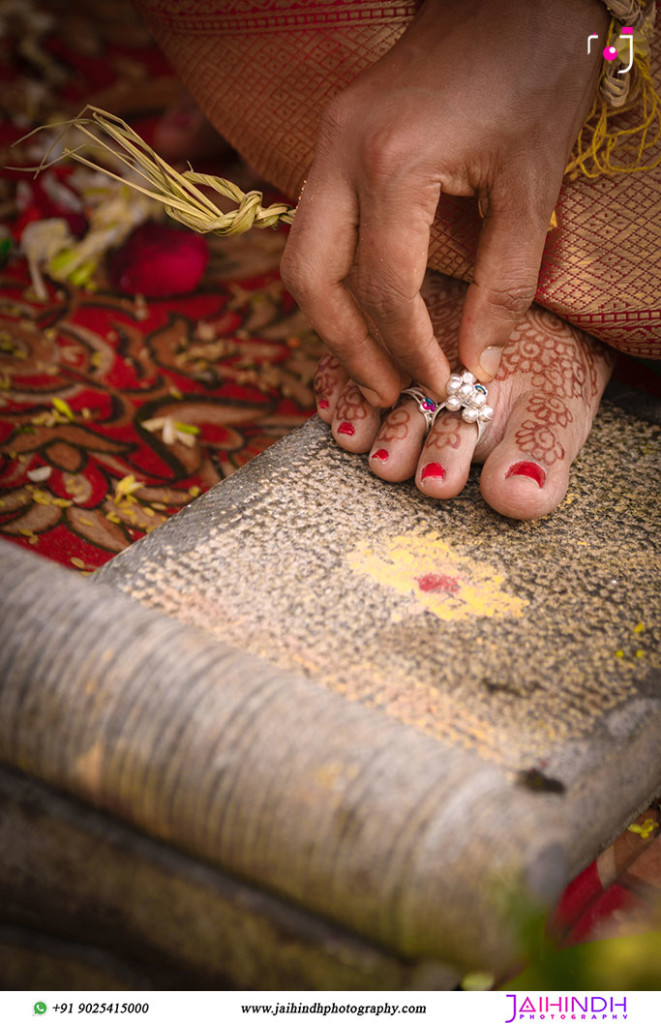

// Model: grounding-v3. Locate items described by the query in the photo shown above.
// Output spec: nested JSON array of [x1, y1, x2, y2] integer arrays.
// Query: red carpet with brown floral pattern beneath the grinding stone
[[0, 3, 661, 983]]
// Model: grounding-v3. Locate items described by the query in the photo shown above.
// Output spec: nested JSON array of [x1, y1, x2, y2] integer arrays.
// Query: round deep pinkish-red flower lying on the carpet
[[107, 221, 209, 298]]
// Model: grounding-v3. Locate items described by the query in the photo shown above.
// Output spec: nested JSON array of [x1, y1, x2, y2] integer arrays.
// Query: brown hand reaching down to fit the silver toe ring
[[282, 0, 608, 408]]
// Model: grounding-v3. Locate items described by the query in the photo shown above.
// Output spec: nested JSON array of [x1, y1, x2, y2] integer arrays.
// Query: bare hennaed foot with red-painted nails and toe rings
[[314, 271, 613, 519]]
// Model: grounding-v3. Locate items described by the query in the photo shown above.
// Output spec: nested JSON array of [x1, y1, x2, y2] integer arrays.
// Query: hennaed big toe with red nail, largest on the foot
[[480, 391, 589, 519]]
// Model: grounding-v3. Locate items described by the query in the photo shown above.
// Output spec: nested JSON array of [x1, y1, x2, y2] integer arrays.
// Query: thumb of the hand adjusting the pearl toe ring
[[458, 194, 553, 383]]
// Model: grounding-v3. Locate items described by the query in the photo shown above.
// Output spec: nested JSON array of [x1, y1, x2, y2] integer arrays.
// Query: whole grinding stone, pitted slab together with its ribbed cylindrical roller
[[0, 395, 661, 971]]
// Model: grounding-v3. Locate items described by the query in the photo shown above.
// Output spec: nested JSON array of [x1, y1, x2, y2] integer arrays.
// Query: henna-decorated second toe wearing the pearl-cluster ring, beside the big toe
[[415, 412, 478, 498]]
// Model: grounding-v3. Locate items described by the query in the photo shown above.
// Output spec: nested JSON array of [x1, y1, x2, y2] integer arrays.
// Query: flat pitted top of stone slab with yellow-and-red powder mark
[[96, 406, 661, 867]]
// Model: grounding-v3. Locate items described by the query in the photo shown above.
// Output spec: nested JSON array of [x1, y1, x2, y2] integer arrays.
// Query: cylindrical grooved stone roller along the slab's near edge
[[0, 544, 568, 970]]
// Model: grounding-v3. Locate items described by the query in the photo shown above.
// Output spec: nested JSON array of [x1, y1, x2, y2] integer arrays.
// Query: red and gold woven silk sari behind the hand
[[139, 0, 661, 358]]
